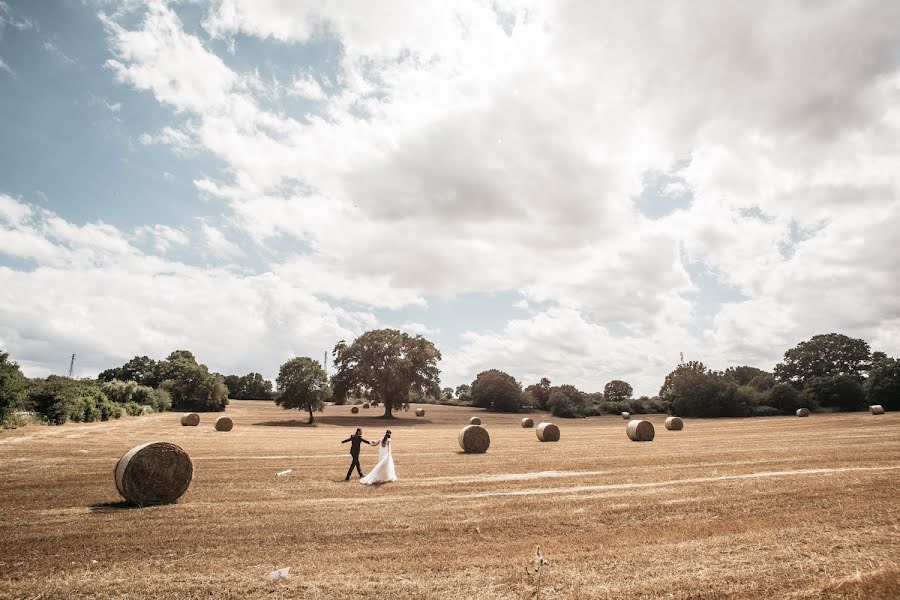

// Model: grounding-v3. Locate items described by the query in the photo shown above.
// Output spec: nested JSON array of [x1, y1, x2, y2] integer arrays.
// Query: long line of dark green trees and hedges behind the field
[[0, 329, 900, 425]]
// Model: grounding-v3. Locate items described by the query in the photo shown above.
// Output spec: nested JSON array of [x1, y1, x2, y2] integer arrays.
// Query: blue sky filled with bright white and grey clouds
[[0, 0, 900, 395]]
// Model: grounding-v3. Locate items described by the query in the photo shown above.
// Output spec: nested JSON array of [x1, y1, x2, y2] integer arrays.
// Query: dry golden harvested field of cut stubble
[[0, 401, 900, 599]]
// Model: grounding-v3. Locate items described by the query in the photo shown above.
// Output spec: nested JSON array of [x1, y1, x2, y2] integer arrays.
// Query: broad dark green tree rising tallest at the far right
[[775, 333, 870, 386]]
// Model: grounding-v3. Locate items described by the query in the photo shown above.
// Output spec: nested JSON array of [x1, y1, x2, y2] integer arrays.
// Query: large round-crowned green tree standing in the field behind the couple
[[332, 329, 441, 418]]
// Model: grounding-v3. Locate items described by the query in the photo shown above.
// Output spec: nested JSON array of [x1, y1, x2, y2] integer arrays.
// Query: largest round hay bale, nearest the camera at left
[[113, 442, 194, 506]]
